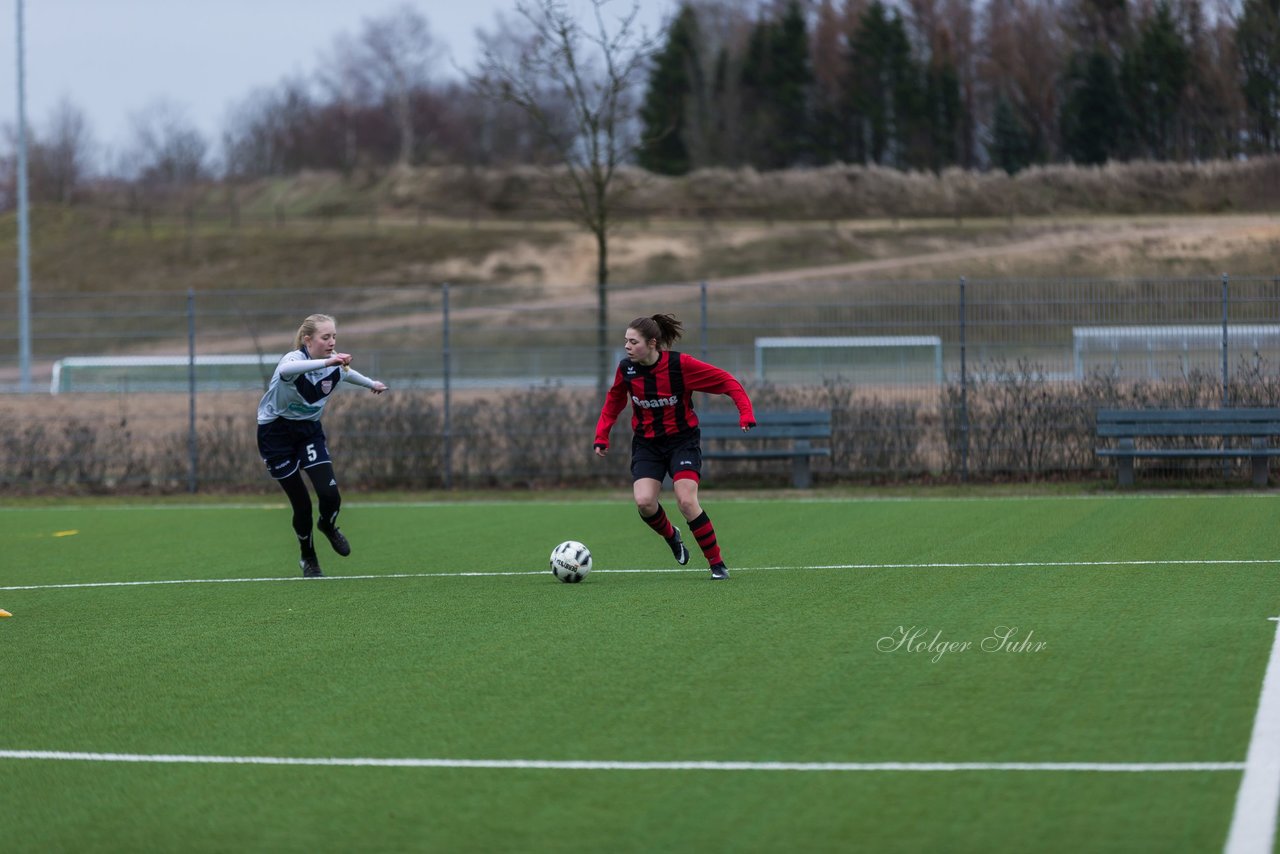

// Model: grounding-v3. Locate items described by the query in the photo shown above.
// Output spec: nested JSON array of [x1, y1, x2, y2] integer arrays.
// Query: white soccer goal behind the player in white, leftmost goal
[[49, 353, 280, 394]]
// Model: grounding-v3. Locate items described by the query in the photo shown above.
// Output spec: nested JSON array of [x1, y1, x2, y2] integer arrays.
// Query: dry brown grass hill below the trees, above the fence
[[0, 157, 1280, 296]]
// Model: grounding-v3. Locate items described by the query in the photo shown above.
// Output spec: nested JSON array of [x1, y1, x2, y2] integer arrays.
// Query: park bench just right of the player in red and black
[[698, 410, 831, 489]]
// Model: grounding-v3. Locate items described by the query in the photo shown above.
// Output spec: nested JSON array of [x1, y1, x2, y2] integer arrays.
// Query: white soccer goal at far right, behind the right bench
[[1071, 324, 1280, 379]]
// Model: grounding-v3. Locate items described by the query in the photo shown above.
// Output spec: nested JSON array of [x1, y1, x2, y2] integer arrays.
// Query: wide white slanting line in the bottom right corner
[[1224, 617, 1280, 854]]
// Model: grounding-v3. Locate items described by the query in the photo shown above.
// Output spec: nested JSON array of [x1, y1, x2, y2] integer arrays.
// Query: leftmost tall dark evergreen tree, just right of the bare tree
[[636, 5, 703, 175]]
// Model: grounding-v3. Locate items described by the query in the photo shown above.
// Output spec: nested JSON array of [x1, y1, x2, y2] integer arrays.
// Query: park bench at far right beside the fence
[[1096, 408, 1280, 487]]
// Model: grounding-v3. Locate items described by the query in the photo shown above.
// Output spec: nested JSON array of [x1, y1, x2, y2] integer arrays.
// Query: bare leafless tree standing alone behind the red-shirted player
[[470, 0, 655, 389]]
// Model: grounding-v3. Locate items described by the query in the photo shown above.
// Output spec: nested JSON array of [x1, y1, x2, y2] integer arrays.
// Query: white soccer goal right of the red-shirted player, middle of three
[[755, 335, 945, 385]]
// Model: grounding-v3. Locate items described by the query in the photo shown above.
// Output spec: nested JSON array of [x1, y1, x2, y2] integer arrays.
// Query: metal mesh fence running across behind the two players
[[0, 277, 1280, 490]]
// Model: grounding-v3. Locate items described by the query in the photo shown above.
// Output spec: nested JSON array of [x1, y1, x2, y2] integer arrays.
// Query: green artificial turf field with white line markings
[[0, 492, 1280, 851]]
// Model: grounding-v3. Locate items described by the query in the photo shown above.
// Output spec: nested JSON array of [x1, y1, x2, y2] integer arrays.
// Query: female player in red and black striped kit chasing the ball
[[595, 314, 755, 580]]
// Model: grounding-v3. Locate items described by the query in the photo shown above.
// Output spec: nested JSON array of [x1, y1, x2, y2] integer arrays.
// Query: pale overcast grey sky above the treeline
[[0, 0, 675, 156]]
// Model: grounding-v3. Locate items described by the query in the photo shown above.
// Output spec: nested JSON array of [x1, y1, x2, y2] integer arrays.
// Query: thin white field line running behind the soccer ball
[[0, 558, 1280, 592]]
